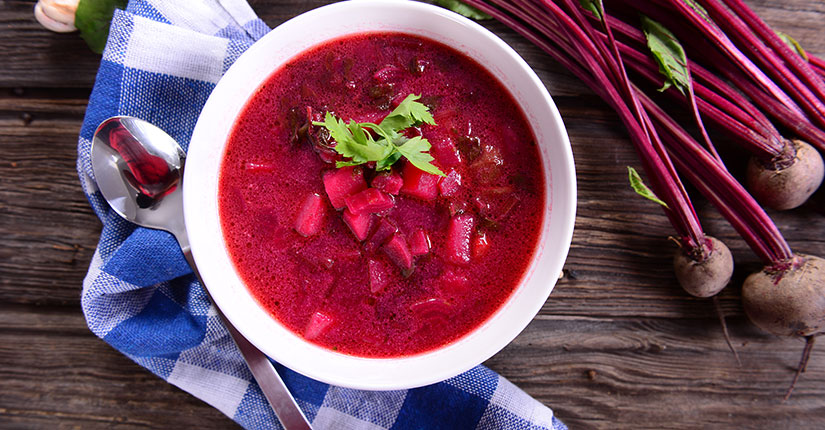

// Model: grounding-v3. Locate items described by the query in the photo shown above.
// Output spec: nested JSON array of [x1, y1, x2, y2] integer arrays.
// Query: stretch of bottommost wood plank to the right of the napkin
[[486, 316, 825, 429]]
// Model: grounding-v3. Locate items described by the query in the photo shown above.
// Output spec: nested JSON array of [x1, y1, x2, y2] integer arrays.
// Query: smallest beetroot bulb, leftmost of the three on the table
[[673, 235, 733, 297]]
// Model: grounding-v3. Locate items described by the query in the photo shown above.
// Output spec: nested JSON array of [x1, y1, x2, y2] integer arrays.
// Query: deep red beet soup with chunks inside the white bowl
[[219, 33, 545, 357]]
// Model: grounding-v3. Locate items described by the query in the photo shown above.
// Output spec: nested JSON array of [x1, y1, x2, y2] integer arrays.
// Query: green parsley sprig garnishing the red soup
[[312, 94, 446, 176]]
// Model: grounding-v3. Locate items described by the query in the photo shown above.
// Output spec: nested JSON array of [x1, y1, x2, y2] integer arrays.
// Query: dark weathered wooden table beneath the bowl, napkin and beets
[[0, 0, 825, 429]]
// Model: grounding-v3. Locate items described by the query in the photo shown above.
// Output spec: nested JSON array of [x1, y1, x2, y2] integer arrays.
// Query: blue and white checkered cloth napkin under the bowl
[[77, 0, 565, 429]]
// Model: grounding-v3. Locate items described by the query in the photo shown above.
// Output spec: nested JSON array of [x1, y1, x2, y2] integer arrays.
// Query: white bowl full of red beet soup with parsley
[[184, 0, 576, 390]]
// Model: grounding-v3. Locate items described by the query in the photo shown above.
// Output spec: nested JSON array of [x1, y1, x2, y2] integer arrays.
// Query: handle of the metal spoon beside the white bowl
[[183, 247, 312, 430]]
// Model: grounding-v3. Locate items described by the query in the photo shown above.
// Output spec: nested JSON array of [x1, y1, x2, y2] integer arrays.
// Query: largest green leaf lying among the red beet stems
[[642, 15, 690, 95]]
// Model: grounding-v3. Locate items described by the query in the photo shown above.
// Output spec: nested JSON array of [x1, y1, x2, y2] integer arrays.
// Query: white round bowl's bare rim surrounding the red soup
[[184, 0, 576, 390]]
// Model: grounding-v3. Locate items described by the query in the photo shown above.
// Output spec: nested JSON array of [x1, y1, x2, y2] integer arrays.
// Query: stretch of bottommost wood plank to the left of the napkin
[[0, 305, 235, 429]]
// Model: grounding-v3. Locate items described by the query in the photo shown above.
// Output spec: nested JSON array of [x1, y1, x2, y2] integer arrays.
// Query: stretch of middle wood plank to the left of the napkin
[[0, 90, 100, 306]]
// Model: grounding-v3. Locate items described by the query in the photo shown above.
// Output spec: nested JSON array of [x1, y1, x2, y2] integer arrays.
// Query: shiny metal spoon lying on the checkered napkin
[[92, 116, 311, 430]]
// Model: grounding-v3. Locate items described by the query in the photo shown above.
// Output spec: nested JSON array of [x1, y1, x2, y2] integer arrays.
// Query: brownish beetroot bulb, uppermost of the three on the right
[[746, 140, 825, 210]]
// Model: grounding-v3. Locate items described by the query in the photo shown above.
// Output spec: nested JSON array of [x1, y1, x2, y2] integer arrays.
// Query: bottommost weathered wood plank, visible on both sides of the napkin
[[0, 305, 825, 429]]
